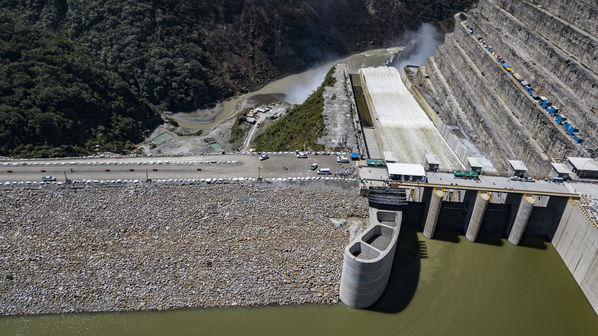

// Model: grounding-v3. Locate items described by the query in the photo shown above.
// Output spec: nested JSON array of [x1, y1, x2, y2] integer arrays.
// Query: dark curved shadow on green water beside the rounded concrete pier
[[368, 225, 428, 314]]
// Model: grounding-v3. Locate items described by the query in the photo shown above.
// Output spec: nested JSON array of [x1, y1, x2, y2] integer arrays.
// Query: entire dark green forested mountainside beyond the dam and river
[[0, 0, 472, 156]]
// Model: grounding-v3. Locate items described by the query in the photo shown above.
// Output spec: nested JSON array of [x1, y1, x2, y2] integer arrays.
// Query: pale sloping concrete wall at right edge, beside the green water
[[552, 201, 598, 314]]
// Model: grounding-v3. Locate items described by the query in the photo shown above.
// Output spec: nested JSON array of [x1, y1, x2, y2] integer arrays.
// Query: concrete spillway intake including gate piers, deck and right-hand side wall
[[364, 182, 598, 313]]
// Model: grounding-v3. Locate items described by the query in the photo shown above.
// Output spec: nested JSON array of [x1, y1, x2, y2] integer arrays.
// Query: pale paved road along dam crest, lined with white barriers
[[0, 152, 351, 182]]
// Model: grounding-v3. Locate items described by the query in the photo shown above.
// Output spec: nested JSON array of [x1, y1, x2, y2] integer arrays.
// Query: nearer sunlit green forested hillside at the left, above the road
[[0, 11, 160, 156]]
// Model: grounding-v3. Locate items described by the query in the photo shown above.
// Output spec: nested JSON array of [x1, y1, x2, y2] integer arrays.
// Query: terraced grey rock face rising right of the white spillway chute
[[416, 0, 598, 175]]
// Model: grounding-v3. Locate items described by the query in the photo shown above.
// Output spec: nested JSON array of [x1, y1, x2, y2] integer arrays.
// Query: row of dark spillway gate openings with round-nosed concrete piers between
[[414, 184, 574, 245]]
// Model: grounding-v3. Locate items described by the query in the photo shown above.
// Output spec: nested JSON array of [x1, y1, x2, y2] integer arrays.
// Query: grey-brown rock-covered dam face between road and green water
[[0, 184, 367, 315]]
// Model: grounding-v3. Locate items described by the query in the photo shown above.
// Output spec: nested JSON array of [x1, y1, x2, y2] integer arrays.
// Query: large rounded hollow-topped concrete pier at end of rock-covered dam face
[[340, 208, 402, 308]]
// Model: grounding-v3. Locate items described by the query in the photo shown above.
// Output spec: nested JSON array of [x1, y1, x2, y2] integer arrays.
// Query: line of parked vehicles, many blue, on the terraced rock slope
[[467, 26, 583, 144]]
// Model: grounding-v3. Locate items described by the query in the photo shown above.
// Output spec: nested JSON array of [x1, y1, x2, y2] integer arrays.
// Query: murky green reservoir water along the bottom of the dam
[[0, 231, 598, 336]]
